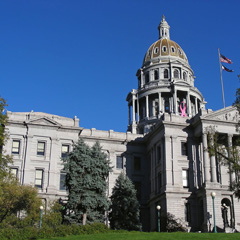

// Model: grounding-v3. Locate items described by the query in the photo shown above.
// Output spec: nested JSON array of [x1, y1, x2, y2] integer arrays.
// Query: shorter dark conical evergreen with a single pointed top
[[109, 173, 141, 231]]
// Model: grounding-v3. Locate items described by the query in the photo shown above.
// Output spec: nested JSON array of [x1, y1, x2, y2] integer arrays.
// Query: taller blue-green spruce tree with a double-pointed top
[[63, 138, 111, 225]]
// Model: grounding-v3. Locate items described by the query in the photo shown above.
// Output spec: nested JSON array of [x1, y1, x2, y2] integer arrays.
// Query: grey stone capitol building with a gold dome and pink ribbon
[[5, 16, 240, 232]]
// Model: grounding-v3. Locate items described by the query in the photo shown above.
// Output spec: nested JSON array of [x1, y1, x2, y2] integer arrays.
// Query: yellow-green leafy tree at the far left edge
[[0, 97, 41, 227]]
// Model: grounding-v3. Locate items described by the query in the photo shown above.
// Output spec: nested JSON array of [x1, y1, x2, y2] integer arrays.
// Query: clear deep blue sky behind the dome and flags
[[0, 0, 240, 132]]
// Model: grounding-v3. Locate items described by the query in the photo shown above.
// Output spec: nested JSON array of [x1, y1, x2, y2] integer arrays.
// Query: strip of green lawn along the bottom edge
[[41, 232, 240, 240]]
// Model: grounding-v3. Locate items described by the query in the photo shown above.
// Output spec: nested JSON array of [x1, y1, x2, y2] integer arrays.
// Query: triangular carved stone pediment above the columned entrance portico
[[201, 106, 239, 122]]
